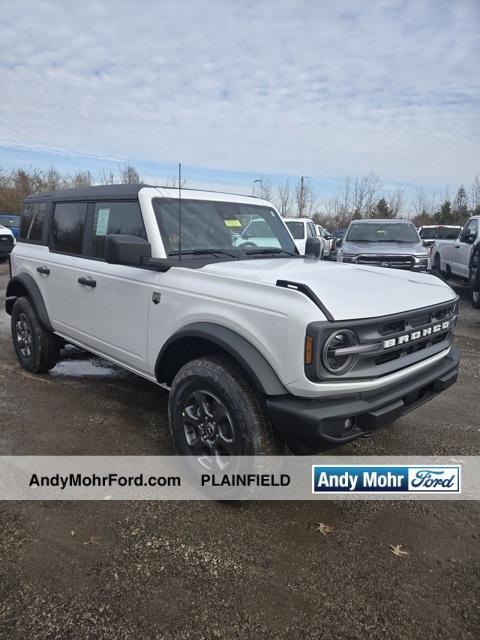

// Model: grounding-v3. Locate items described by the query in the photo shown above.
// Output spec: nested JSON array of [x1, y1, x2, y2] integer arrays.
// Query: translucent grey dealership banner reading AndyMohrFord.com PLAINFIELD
[[0, 455, 480, 500]]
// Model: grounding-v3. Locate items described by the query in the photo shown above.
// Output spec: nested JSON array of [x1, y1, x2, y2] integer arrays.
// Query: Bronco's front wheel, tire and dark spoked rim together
[[168, 355, 282, 460]]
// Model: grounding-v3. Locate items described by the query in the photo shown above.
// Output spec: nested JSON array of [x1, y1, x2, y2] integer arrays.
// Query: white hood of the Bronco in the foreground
[[201, 258, 456, 320]]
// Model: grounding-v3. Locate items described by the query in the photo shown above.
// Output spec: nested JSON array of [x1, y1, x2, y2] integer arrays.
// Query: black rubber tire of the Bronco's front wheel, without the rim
[[168, 355, 283, 456]]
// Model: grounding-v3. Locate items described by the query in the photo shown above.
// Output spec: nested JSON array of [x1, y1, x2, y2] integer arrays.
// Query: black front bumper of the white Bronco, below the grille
[[266, 347, 460, 455]]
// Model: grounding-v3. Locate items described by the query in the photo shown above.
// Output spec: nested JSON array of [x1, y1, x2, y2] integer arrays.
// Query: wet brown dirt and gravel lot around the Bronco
[[0, 265, 480, 640]]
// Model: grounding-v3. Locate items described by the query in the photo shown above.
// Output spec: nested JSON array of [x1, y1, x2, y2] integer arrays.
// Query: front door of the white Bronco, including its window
[[75, 200, 155, 372]]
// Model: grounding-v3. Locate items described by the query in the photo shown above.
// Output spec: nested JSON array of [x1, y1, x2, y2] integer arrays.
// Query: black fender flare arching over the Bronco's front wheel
[[155, 322, 288, 396]]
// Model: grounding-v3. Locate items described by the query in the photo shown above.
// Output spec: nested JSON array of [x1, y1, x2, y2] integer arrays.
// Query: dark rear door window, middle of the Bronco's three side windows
[[50, 202, 87, 255]]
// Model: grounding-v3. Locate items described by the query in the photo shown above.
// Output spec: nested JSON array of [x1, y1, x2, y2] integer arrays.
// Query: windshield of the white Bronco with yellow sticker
[[153, 198, 297, 257]]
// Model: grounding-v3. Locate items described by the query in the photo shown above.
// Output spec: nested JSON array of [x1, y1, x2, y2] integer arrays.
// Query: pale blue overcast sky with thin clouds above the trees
[[0, 0, 480, 195]]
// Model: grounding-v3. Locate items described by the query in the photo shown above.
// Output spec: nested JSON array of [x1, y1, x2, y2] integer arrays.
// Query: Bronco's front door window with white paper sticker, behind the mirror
[[92, 202, 147, 258]]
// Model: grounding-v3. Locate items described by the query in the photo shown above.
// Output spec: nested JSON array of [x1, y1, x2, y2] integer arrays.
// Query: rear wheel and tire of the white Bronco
[[11, 298, 61, 373]]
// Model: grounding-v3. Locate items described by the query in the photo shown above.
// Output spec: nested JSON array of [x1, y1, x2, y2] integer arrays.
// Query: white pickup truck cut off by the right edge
[[430, 216, 480, 309]]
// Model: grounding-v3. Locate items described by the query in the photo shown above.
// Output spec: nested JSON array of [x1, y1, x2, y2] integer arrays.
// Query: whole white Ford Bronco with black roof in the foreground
[[6, 185, 459, 457]]
